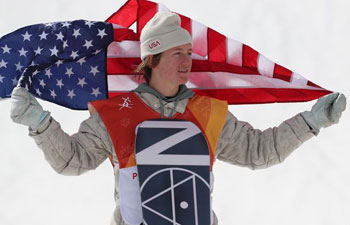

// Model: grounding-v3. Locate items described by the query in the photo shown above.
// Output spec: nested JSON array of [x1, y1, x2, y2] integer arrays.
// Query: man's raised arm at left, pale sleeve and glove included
[[11, 88, 113, 175]]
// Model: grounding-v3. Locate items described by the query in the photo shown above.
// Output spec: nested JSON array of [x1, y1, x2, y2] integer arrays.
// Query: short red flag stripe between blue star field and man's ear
[[107, 58, 141, 75]]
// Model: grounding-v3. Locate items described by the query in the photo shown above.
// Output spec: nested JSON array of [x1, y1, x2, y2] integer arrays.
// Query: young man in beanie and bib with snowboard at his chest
[[11, 12, 346, 225]]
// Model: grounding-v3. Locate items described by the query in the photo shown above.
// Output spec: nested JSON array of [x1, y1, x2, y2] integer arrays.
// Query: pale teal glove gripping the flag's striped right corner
[[301, 93, 346, 134]]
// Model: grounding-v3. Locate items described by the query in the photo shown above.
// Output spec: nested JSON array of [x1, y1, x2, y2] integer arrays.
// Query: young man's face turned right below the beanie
[[150, 44, 192, 96]]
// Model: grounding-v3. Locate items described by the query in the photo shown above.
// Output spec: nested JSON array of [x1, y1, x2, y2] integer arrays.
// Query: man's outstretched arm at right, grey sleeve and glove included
[[216, 93, 346, 169]]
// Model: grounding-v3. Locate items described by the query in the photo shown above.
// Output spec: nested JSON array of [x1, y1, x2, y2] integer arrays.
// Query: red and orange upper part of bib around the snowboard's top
[[91, 92, 228, 169]]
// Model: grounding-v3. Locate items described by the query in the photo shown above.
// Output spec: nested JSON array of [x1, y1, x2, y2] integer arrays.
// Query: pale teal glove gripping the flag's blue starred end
[[10, 87, 51, 130]]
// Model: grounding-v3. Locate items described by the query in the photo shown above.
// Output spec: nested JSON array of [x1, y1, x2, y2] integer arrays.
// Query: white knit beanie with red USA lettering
[[140, 12, 192, 60]]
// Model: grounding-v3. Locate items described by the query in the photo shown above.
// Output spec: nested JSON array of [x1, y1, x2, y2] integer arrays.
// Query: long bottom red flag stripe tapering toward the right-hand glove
[[193, 88, 331, 104]]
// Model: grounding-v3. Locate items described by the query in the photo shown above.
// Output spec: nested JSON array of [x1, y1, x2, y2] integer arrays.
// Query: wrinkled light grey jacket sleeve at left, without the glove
[[29, 113, 113, 175]]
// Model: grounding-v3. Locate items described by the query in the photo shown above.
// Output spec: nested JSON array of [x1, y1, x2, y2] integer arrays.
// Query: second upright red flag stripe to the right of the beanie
[[208, 28, 226, 62]]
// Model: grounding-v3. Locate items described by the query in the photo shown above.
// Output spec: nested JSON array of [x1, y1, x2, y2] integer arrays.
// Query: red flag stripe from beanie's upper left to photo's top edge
[[137, 0, 158, 34]]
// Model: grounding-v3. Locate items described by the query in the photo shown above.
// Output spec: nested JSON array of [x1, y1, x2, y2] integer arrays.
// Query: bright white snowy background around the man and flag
[[0, 0, 350, 225]]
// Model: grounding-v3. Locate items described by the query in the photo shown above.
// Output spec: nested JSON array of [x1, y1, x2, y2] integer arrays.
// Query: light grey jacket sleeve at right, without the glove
[[216, 112, 314, 170]]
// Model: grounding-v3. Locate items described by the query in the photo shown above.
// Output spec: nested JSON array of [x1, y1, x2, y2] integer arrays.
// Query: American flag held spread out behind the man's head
[[0, 0, 331, 109]]
